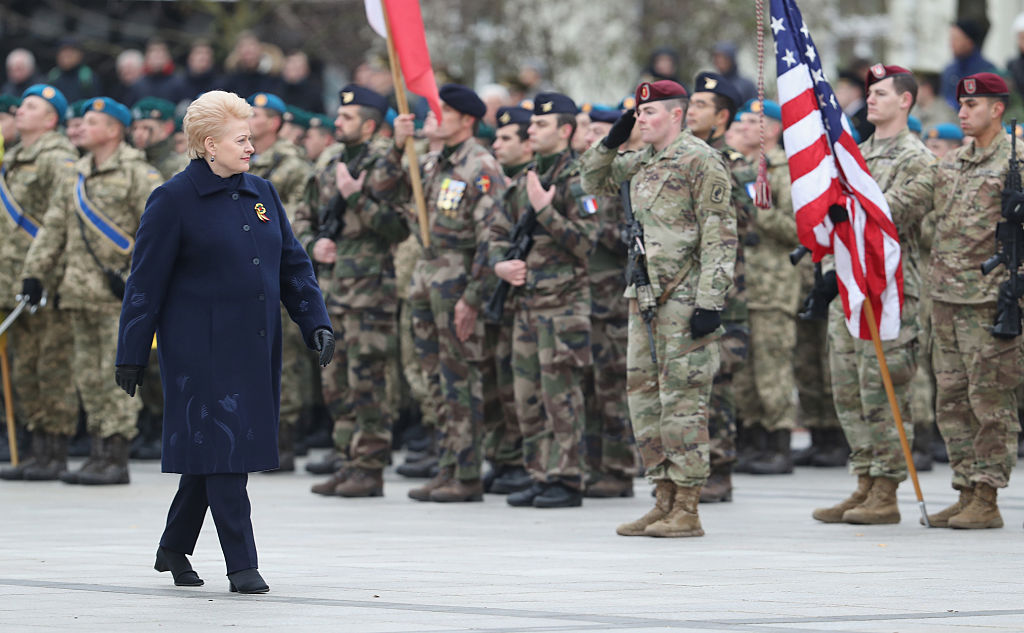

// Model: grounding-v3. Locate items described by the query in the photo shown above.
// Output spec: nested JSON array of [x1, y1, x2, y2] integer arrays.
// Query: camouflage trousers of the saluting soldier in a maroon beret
[[627, 298, 721, 488]]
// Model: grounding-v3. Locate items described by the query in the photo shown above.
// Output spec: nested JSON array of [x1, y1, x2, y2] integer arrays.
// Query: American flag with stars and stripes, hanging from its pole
[[771, 0, 903, 340]]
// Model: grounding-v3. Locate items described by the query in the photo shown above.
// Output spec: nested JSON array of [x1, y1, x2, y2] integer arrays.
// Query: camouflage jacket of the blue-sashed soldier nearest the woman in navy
[[22, 143, 163, 311]]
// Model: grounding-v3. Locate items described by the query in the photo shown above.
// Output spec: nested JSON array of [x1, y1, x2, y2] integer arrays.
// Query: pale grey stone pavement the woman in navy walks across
[[0, 446, 1024, 633]]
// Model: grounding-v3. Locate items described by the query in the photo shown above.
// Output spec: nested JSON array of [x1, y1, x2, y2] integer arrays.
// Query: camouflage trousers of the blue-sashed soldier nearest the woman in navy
[[68, 310, 142, 439]]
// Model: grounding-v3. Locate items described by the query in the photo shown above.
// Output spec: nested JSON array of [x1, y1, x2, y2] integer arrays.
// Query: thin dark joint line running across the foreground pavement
[[0, 578, 1024, 633]]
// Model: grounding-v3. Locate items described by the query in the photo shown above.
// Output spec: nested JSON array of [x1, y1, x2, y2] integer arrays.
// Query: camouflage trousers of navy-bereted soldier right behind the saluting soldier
[[708, 321, 751, 470]]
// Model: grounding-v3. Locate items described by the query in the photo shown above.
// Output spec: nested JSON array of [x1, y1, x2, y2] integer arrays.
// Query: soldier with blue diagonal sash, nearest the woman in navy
[[22, 97, 163, 484]]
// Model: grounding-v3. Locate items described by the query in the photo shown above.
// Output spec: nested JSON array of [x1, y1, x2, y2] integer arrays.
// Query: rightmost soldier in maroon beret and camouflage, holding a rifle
[[928, 73, 1024, 529]]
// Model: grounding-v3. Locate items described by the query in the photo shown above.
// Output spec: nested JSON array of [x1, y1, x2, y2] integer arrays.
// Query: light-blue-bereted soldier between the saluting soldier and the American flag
[[735, 100, 800, 474]]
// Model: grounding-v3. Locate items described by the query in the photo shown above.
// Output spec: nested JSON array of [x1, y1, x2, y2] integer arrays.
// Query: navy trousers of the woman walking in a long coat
[[160, 472, 259, 574]]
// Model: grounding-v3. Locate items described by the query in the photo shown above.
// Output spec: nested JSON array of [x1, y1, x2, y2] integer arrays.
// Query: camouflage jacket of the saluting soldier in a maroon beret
[[581, 130, 736, 310]]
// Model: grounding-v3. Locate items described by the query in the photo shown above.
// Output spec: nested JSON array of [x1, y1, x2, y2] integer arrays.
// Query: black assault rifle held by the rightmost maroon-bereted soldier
[[981, 119, 1024, 338]]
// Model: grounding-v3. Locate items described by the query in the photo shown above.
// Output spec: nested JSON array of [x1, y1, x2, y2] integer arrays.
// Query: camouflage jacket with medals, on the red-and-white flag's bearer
[[369, 138, 505, 308]]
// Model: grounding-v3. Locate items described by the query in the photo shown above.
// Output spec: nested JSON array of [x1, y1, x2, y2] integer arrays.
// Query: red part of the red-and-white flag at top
[[382, 0, 441, 121]]
